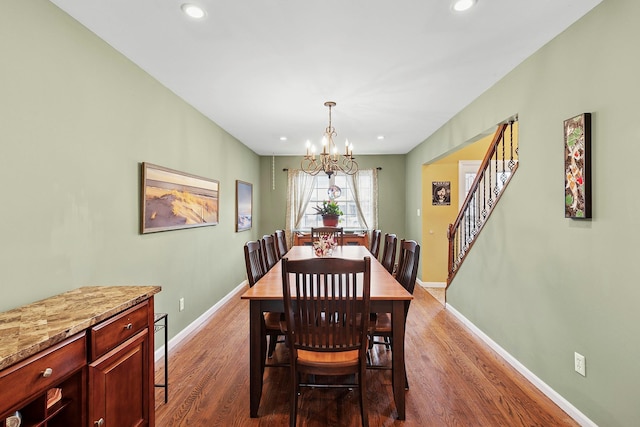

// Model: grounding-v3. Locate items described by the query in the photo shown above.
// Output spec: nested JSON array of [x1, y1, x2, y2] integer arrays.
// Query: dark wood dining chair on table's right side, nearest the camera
[[369, 239, 420, 389]]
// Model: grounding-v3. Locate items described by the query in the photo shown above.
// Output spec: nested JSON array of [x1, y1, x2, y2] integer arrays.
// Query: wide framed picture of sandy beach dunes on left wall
[[140, 162, 220, 234]]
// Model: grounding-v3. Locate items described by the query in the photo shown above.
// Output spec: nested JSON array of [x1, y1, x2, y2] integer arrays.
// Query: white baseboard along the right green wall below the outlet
[[446, 303, 598, 427]]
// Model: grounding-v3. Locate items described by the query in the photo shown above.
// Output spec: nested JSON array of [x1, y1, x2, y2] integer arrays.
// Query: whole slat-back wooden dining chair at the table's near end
[[282, 257, 371, 427]]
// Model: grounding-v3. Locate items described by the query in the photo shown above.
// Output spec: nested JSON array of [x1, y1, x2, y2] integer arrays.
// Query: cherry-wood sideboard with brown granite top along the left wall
[[0, 286, 161, 427]]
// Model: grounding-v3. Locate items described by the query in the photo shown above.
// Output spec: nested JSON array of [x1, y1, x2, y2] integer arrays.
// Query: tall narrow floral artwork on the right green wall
[[564, 113, 591, 219]]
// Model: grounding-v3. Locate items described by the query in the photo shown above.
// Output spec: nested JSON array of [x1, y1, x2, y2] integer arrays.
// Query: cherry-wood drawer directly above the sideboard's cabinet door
[[90, 300, 149, 360]]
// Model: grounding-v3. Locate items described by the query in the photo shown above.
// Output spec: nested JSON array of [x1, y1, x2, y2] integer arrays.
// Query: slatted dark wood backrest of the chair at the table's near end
[[282, 257, 371, 358]]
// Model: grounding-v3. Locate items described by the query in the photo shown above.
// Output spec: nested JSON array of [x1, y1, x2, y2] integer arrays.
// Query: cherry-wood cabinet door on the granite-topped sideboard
[[89, 329, 150, 427]]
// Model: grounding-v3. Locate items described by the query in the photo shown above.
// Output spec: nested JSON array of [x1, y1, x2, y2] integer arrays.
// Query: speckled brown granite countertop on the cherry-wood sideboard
[[0, 286, 162, 370]]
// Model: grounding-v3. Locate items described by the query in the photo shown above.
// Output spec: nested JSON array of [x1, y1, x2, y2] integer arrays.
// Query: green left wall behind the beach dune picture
[[0, 0, 260, 336]]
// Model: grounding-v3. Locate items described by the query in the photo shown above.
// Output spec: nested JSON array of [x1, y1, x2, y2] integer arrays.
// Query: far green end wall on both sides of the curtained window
[[260, 154, 410, 247]]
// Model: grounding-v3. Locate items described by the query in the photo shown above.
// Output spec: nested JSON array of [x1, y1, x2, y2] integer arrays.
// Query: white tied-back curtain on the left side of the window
[[285, 169, 316, 247]]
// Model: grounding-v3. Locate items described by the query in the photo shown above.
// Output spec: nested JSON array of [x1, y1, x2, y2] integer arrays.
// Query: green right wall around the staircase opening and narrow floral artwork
[[407, 0, 640, 427]]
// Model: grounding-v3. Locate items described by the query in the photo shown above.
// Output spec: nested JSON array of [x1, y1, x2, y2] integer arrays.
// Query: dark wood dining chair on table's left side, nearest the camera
[[244, 240, 284, 364]]
